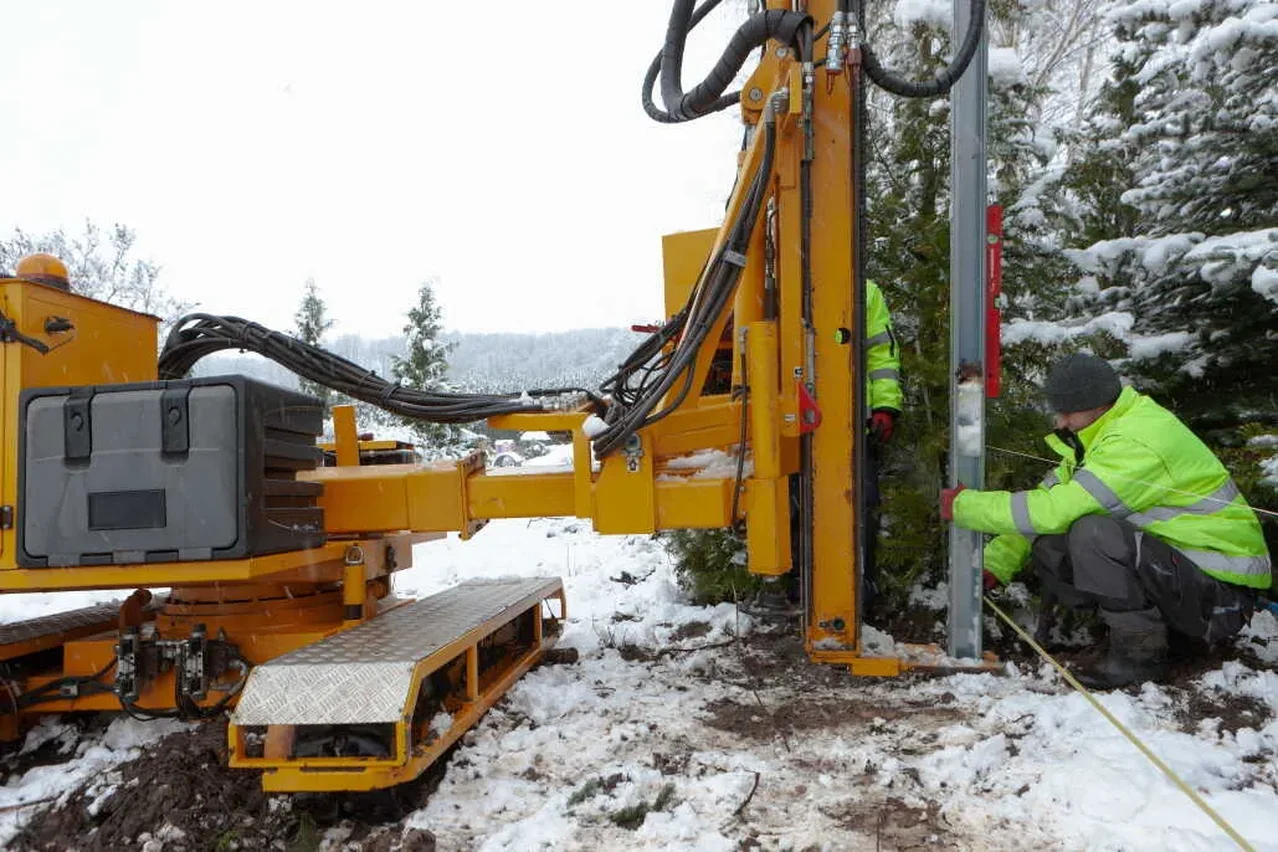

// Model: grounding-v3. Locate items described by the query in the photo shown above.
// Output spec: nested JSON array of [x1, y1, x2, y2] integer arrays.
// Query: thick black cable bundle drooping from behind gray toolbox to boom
[[158, 313, 603, 423]]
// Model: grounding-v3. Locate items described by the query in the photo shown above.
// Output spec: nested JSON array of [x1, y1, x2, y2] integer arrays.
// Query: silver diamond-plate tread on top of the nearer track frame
[[231, 577, 560, 727]]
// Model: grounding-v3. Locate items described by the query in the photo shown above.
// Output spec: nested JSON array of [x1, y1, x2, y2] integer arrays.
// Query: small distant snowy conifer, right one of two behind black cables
[[392, 281, 461, 457]]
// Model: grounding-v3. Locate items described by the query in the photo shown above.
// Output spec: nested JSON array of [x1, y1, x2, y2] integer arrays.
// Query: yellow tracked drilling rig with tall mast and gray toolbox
[[0, 0, 984, 791]]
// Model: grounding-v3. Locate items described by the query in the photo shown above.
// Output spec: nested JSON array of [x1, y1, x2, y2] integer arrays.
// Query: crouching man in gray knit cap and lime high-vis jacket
[[941, 354, 1270, 688]]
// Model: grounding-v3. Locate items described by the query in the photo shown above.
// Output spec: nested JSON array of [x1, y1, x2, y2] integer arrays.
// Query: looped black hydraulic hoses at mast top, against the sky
[[643, 0, 812, 124]]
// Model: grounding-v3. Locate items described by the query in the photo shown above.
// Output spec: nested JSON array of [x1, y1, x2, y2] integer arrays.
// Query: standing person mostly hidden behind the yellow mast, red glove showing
[[861, 278, 904, 608]]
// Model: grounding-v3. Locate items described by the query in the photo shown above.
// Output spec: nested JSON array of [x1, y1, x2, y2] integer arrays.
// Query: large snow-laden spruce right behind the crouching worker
[[1070, 0, 1278, 543]]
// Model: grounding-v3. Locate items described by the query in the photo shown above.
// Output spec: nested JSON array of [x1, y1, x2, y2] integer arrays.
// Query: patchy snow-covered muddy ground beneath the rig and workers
[[0, 449, 1278, 852]]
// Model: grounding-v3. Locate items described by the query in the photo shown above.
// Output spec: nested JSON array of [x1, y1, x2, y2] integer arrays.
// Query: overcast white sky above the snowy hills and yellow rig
[[0, 0, 744, 335]]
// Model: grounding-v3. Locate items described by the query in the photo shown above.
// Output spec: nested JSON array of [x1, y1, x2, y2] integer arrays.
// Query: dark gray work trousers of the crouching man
[[1031, 515, 1256, 643]]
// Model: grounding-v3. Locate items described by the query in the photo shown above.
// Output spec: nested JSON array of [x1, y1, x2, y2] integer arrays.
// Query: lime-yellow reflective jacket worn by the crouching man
[[953, 387, 1270, 589]]
